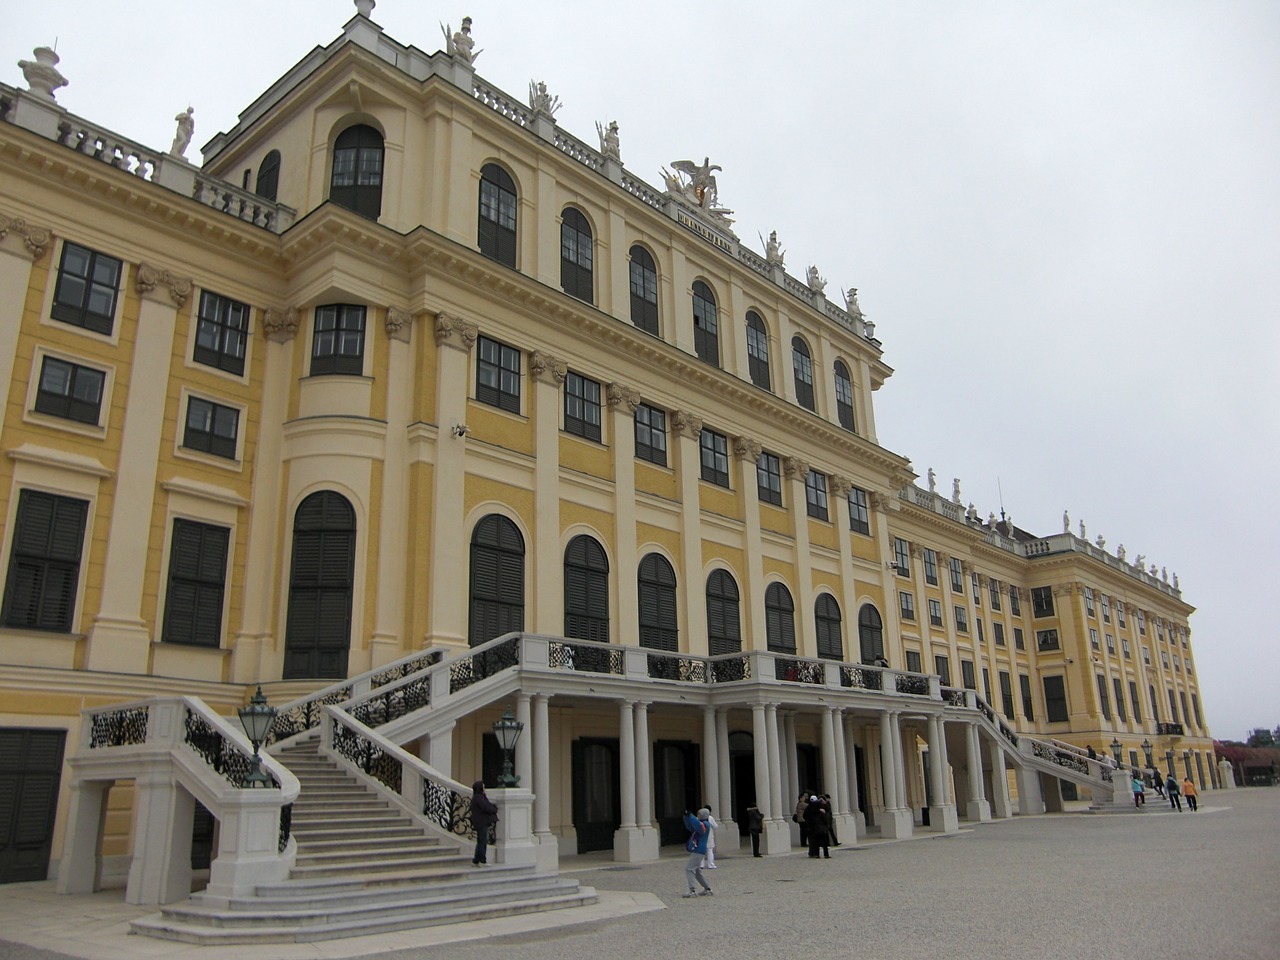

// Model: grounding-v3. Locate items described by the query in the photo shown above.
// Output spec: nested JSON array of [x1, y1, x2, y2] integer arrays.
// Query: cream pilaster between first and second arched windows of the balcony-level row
[[529, 351, 568, 636]]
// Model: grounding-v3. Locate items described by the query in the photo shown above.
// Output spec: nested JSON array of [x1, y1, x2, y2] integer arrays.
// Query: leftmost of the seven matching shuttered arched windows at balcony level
[[467, 513, 525, 646]]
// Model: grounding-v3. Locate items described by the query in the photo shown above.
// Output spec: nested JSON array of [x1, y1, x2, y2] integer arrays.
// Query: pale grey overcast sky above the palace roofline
[[0, 0, 1280, 739]]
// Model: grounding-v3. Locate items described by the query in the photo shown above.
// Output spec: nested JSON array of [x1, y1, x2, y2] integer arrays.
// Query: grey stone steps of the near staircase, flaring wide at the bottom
[[132, 735, 596, 945]]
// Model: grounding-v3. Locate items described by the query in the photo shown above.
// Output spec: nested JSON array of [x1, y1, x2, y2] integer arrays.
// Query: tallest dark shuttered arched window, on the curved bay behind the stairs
[[284, 490, 356, 680]]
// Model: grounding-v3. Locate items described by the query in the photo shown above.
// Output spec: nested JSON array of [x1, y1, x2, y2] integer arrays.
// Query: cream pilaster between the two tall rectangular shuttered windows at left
[[84, 264, 190, 675]]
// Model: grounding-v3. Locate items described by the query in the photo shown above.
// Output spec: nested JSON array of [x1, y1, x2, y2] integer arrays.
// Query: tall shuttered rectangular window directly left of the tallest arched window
[[163, 520, 230, 646]]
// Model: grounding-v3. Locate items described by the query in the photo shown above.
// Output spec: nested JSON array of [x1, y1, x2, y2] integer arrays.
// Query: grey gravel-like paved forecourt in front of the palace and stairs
[[0, 788, 1280, 960]]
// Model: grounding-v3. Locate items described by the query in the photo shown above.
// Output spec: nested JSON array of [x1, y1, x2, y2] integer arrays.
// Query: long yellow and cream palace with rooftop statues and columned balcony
[[0, 0, 1216, 942]]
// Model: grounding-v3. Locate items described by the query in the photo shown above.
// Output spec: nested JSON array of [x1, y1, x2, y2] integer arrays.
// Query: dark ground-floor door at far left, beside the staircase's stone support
[[0, 728, 67, 883]]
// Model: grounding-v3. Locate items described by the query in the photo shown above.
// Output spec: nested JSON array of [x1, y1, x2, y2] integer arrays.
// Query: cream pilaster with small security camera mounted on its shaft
[[426, 314, 480, 646]]
